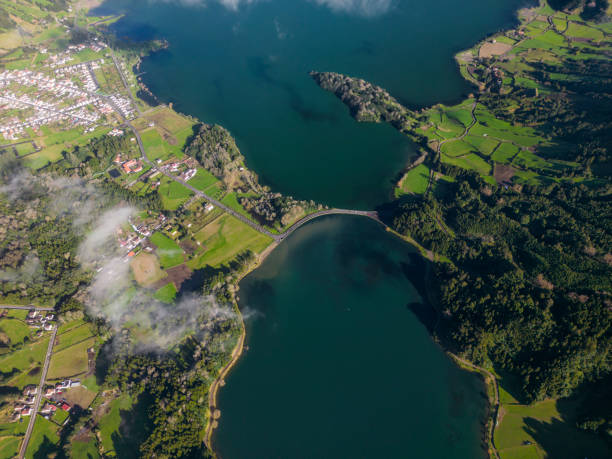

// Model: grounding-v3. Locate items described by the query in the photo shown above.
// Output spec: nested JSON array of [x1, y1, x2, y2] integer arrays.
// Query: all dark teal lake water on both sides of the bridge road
[[93, 0, 524, 459]]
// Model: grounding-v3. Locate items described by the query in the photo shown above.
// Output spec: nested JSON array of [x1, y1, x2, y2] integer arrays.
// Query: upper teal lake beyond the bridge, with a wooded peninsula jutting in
[[94, 0, 522, 209]]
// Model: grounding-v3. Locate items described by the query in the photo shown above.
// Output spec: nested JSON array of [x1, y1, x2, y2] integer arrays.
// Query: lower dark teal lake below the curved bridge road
[[213, 216, 485, 459]]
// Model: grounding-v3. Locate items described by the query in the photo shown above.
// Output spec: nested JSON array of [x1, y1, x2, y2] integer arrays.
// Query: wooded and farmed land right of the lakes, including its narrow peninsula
[[311, 1, 612, 458]]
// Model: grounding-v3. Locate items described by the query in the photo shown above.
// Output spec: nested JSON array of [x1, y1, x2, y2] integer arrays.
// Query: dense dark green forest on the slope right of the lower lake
[[393, 171, 612, 400]]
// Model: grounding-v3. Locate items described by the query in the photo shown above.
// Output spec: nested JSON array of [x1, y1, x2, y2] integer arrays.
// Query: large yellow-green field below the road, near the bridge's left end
[[188, 214, 272, 269]]
